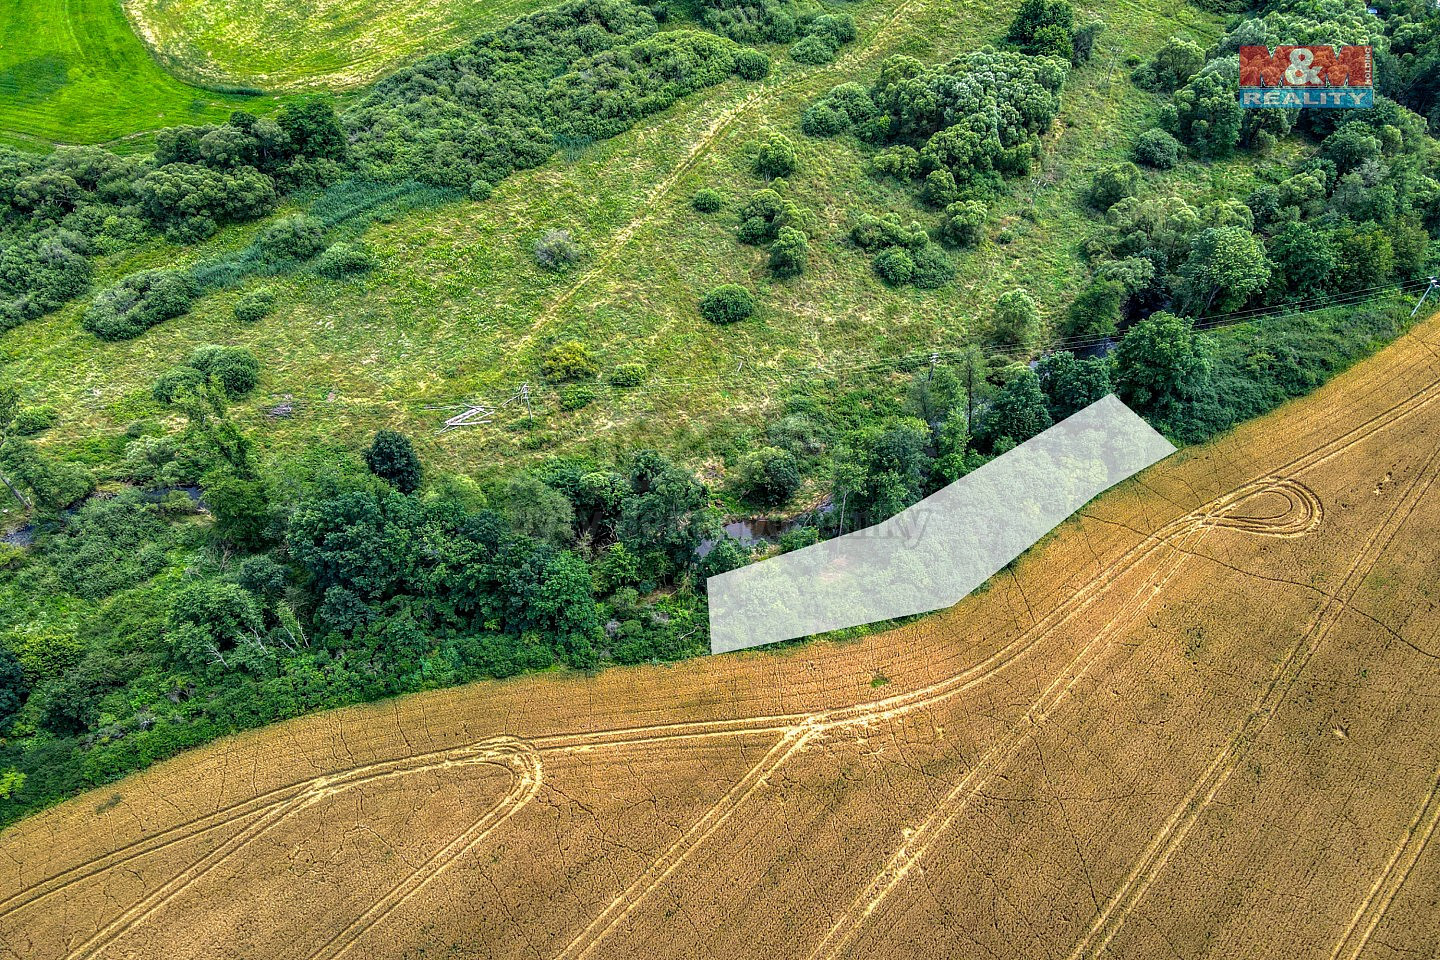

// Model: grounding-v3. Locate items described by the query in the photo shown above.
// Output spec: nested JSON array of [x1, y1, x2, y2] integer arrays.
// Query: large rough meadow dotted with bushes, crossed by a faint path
[[0, 0, 1226, 472]]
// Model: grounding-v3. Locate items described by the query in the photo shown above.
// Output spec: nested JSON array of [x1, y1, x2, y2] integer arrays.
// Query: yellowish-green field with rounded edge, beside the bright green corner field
[[125, 0, 561, 89]]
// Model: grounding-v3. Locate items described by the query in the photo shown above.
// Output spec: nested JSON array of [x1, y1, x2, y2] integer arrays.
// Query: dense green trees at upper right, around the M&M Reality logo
[[1063, 0, 1440, 349]]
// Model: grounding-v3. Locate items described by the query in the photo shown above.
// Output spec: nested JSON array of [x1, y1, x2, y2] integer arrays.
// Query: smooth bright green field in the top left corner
[[0, 0, 282, 145]]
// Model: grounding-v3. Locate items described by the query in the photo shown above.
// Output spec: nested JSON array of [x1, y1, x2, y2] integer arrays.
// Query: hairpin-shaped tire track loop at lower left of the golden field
[[53, 737, 540, 960]]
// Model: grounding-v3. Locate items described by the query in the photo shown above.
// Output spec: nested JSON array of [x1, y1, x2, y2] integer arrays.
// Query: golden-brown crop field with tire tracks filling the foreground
[[0, 312, 1440, 960]]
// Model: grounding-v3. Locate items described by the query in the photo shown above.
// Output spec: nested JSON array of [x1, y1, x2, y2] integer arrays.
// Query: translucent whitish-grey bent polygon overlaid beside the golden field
[[708, 394, 1175, 653]]
